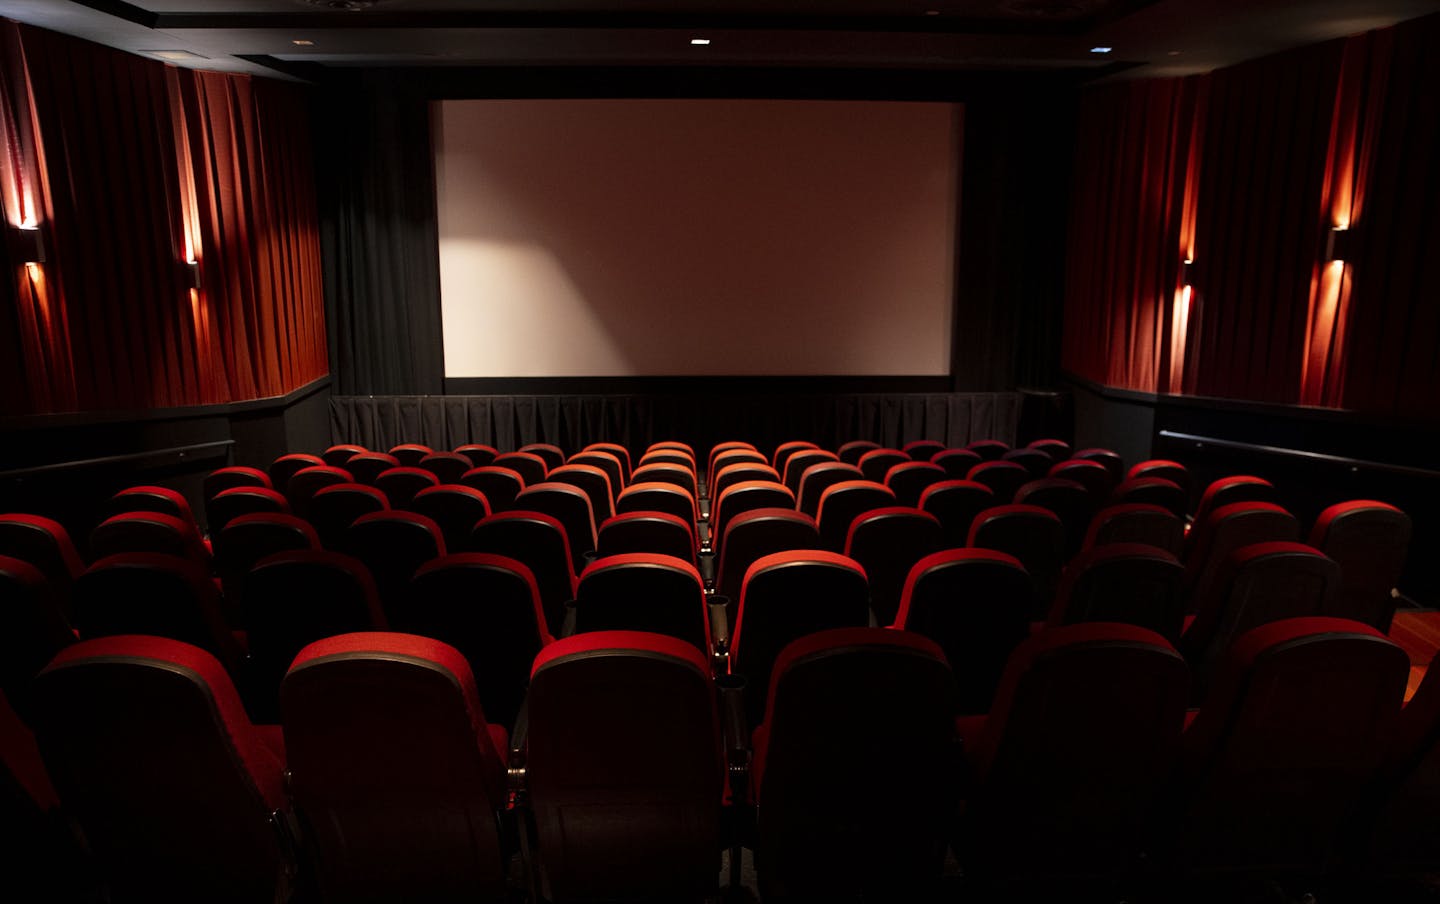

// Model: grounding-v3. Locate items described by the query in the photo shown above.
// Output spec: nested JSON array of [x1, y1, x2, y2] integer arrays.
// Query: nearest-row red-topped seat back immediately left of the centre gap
[[526, 630, 726, 904]]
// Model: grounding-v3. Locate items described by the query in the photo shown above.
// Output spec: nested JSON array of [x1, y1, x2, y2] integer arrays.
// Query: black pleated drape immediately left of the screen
[[315, 81, 445, 394]]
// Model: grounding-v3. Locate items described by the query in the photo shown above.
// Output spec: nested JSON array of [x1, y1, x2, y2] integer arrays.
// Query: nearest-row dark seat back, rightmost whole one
[[1174, 618, 1410, 875]]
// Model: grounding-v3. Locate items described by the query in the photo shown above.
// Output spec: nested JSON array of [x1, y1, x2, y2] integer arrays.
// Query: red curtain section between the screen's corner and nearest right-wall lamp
[[1063, 78, 1204, 392]]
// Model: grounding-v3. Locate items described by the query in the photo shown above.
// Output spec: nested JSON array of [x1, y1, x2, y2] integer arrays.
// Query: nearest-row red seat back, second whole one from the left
[[281, 632, 508, 903]]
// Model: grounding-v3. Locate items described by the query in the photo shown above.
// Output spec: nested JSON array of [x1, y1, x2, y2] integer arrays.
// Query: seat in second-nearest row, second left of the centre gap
[[411, 553, 552, 726]]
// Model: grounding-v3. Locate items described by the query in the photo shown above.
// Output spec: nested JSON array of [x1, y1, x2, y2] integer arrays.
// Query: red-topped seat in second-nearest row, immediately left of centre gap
[[573, 553, 713, 655]]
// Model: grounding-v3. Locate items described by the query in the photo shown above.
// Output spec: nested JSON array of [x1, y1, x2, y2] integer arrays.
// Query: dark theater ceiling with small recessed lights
[[0, 0, 1440, 79]]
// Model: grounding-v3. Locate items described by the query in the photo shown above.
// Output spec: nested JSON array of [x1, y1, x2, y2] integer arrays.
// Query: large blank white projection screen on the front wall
[[432, 99, 962, 377]]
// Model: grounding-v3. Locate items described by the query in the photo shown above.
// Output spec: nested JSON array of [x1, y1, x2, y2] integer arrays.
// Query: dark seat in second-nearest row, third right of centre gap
[[1048, 543, 1185, 643]]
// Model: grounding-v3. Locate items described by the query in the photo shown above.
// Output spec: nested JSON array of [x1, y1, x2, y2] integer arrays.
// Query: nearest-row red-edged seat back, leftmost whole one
[[35, 635, 292, 904]]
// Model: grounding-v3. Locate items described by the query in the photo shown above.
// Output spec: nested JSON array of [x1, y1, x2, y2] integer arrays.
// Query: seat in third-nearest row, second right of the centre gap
[[845, 505, 945, 625]]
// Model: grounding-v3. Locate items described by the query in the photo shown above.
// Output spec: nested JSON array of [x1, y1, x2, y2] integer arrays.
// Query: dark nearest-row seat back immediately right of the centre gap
[[753, 628, 958, 901]]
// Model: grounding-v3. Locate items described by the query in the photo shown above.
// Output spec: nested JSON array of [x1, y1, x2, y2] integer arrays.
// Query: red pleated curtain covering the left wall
[[0, 23, 325, 413]]
